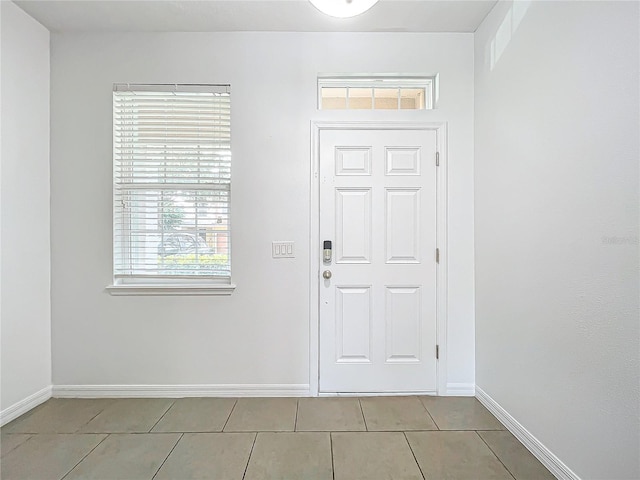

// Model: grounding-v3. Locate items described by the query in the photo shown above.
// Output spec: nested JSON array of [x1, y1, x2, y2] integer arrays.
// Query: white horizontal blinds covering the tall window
[[113, 85, 231, 278]]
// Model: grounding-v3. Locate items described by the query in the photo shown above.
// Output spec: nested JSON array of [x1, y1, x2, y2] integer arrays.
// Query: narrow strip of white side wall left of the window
[[0, 2, 51, 416]]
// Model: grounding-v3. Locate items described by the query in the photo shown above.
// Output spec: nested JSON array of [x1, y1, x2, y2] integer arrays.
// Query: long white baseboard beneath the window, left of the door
[[53, 384, 309, 398]]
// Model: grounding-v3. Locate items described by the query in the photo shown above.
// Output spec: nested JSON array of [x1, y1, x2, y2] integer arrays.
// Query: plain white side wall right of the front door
[[475, 2, 640, 479]]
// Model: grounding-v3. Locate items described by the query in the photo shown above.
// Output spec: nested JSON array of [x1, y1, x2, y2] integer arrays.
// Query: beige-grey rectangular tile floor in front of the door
[[0, 397, 554, 480]]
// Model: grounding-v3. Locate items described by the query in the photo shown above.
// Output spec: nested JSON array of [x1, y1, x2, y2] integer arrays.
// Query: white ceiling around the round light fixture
[[15, 0, 496, 32]]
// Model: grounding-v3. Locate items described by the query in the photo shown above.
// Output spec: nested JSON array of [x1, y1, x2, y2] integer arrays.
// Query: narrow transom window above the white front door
[[318, 75, 435, 110]]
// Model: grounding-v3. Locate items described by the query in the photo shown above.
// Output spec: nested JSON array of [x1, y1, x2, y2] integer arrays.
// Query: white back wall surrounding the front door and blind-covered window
[[51, 33, 474, 392]]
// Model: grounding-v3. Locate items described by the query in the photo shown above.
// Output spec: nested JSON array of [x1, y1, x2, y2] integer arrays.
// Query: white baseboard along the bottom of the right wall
[[476, 385, 580, 480]]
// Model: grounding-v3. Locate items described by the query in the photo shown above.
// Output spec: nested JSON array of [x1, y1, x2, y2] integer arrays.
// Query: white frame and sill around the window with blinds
[[106, 84, 236, 295]]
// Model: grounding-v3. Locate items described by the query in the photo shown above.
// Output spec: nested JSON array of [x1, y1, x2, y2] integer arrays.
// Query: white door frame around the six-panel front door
[[309, 120, 448, 397]]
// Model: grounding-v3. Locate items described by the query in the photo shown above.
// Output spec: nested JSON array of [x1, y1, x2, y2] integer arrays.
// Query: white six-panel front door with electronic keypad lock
[[319, 128, 437, 393]]
